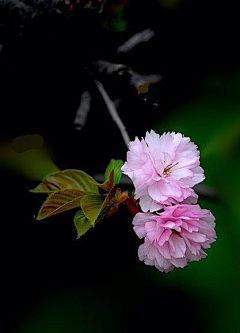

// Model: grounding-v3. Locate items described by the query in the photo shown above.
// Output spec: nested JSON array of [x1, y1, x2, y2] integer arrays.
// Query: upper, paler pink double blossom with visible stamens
[[122, 130, 205, 212]]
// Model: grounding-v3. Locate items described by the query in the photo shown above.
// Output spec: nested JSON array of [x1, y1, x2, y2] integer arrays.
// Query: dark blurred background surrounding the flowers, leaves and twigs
[[0, 0, 240, 333]]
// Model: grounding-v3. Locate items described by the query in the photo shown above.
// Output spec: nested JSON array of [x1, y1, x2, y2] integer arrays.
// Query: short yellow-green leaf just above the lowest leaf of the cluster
[[80, 194, 105, 225]]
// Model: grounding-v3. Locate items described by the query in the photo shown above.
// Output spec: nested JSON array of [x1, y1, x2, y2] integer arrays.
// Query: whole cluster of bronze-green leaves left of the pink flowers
[[30, 159, 129, 238]]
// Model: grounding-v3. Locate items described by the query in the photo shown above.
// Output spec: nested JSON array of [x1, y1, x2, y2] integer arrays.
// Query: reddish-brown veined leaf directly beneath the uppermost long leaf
[[37, 189, 86, 220]]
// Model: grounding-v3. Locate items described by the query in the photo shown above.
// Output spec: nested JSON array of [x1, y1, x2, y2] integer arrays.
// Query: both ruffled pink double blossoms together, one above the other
[[122, 130, 217, 272]]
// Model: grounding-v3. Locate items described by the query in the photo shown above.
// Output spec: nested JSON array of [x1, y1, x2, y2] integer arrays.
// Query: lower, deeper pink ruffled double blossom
[[133, 204, 217, 272]]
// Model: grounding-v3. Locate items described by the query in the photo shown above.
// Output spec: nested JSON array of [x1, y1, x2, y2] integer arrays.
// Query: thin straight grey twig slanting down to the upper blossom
[[94, 80, 130, 147]]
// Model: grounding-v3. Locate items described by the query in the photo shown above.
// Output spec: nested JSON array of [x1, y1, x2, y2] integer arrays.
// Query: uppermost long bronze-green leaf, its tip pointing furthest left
[[30, 169, 98, 193]]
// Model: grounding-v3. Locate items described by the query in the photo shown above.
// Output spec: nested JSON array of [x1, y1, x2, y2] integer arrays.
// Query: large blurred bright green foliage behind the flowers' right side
[[154, 73, 240, 332]]
